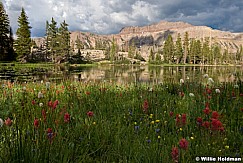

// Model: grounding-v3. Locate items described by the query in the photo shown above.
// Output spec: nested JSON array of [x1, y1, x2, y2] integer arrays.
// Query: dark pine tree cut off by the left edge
[[0, 2, 10, 61]]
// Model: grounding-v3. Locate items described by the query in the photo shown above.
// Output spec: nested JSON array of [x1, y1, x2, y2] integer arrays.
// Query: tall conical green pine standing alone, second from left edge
[[15, 8, 31, 58]]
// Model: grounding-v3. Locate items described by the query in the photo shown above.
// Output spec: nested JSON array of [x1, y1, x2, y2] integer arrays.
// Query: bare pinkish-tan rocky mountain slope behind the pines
[[34, 21, 243, 58]]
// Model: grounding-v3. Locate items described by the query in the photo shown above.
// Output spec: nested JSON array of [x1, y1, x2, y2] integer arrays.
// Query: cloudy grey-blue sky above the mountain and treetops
[[2, 0, 243, 37]]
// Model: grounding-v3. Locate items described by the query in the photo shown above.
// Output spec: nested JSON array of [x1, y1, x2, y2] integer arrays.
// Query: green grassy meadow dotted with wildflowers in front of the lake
[[0, 79, 243, 162]]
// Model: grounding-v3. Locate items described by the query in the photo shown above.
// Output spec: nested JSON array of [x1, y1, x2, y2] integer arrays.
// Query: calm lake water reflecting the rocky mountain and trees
[[0, 65, 243, 84]]
